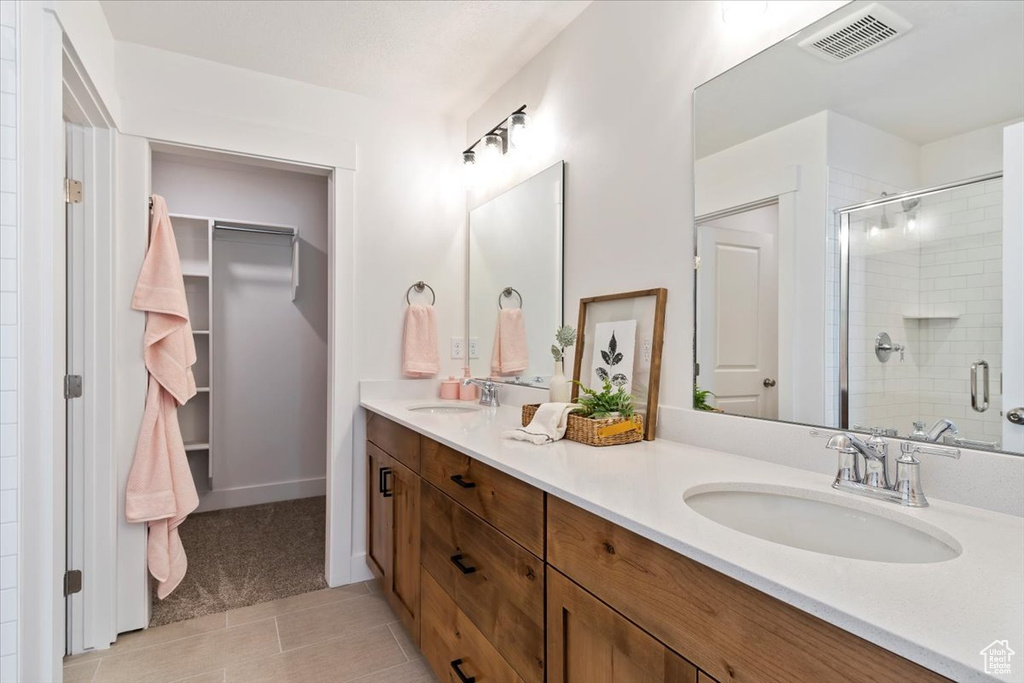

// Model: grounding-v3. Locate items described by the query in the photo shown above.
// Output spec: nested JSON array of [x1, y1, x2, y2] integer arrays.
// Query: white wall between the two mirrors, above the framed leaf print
[[466, 2, 844, 417]]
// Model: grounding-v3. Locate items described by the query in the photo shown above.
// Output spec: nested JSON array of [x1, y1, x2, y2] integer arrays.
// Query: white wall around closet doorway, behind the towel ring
[[117, 43, 465, 379]]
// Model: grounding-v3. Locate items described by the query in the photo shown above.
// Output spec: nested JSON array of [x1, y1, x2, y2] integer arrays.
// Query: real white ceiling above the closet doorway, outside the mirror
[[101, 0, 590, 117]]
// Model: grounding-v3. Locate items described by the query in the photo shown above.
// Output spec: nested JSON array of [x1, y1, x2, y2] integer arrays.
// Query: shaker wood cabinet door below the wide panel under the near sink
[[548, 567, 697, 683]]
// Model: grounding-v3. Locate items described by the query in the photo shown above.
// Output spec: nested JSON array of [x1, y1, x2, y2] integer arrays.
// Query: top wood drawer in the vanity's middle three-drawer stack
[[422, 438, 544, 558]]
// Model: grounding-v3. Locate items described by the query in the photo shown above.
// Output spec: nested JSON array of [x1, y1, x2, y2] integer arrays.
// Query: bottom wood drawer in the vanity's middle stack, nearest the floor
[[420, 568, 523, 683]]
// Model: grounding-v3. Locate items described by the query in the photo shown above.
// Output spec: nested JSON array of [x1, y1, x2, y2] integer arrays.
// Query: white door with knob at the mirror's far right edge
[[1001, 123, 1024, 453]]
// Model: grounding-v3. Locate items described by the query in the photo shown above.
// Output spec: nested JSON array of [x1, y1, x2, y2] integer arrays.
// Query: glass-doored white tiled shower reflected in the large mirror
[[834, 174, 1002, 450]]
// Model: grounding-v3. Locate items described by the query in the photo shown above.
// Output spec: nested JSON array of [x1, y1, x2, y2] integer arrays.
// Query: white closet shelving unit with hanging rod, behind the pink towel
[[169, 213, 299, 484]]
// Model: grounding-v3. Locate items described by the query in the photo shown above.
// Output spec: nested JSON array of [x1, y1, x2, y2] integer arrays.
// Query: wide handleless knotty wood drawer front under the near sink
[[548, 496, 947, 683]]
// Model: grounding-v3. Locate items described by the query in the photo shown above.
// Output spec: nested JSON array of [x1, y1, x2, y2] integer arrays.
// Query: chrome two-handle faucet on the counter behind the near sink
[[825, 432, 961, 508]]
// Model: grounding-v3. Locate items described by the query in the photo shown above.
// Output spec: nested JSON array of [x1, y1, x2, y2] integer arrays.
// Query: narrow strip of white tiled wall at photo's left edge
[[0, 2, 19, 683]]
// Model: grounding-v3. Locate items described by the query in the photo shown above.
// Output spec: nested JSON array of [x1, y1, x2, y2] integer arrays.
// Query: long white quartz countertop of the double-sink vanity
[[361, 399, 1024, 681]]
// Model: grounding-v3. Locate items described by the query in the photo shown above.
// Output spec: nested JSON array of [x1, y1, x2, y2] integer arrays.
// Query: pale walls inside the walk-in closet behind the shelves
[[153, 154, 329, 511]]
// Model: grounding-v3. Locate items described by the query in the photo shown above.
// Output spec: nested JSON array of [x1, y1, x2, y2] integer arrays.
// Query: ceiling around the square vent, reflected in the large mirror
[[694, 0, 1024, 158]]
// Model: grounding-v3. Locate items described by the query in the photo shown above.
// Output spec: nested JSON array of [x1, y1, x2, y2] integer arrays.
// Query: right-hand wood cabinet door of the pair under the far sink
[[384, 458, 420, 644]]
